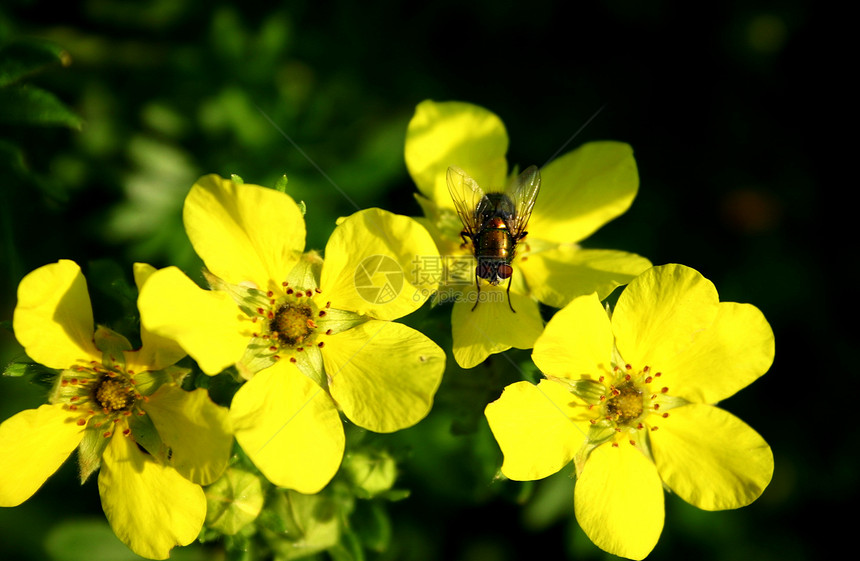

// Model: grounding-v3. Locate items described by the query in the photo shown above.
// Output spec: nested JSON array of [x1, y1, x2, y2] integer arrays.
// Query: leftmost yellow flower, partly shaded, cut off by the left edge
[[0, 260, 233, 559]]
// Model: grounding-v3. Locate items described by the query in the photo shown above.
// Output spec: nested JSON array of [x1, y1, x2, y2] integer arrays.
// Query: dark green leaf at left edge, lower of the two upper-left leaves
[[0, 85, 82, 130]]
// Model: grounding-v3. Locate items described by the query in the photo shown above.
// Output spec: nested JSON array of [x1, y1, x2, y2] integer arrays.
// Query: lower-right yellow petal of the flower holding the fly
[[519, 245, 651, 308]]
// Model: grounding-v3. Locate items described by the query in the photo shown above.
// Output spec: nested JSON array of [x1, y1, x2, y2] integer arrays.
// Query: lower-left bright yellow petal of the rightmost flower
[[484, 380, 589, 481]]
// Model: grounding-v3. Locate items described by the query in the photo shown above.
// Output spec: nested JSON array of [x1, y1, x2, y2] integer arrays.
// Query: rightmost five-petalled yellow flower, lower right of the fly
[[485, 265, 774, 559]]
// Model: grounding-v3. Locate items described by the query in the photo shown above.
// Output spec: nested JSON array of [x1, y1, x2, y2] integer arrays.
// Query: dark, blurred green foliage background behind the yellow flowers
[[0, 0, 858, 560]]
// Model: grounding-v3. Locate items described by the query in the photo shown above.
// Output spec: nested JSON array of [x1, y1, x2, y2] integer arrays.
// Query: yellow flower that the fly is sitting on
[[405, 100, 650, 368]]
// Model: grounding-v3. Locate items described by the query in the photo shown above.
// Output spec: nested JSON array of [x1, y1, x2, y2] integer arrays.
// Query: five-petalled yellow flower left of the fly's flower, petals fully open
[[141, 175, 444, 493]]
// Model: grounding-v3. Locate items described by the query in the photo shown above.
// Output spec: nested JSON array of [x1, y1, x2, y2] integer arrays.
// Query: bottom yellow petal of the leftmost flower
[[99, 433, 206, 559]]
